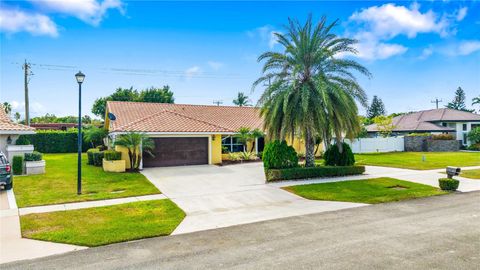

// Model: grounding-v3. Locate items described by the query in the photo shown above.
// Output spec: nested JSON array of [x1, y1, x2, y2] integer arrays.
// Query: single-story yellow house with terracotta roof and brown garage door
[[105, 101, 312, 167]]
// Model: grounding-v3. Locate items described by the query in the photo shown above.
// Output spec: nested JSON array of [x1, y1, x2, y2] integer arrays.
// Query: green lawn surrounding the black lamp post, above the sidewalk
[[14, 153, 160, 207]]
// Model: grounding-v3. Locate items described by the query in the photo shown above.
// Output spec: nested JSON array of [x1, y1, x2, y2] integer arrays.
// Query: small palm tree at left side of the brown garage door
[[115, 132, 155, 171]]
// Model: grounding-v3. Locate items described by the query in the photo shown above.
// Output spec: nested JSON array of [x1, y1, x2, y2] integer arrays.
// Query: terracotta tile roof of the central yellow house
[[107, 101, 263, 133]]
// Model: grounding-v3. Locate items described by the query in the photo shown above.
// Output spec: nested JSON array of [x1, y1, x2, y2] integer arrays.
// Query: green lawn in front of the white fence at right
[[355, 152, 480, 170]]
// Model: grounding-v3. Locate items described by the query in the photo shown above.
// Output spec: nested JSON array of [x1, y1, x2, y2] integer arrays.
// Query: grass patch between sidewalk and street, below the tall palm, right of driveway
[[284, 177, 446, 204]]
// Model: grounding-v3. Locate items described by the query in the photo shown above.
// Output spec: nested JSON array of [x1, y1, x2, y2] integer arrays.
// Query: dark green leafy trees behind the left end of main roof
[[92, 85, 174, 119]]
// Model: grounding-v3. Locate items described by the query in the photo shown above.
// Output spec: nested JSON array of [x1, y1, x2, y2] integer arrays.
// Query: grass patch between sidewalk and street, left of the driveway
[[20, 199, 185, 247]]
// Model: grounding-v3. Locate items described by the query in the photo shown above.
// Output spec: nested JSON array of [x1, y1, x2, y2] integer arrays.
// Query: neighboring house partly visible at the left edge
[[0, 105, 35, 159]]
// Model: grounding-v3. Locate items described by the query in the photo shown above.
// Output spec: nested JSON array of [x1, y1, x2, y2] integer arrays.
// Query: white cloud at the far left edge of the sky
[[0, 7, 58, 37]]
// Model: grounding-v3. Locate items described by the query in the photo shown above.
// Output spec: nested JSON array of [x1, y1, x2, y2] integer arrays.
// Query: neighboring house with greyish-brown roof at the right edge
[[367, 108, 480, 145]]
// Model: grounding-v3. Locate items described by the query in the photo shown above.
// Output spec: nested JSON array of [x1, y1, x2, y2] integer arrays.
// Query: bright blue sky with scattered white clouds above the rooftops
[[0, 0, 480, 118]]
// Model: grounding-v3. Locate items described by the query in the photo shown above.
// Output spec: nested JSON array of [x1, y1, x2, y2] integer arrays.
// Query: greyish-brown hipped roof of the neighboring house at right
[[367, 108, 480, 132]]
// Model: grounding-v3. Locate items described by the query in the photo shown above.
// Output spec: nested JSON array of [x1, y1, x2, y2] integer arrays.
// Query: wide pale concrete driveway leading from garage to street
[[142, 163, 364, 234]]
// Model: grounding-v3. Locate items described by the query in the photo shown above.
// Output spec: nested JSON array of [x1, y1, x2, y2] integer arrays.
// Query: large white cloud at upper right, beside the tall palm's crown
[[349, 3, 449, 39]]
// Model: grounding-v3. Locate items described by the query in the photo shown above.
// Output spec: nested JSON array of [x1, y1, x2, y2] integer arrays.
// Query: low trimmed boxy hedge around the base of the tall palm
[[265, 166, 365, 182]]
